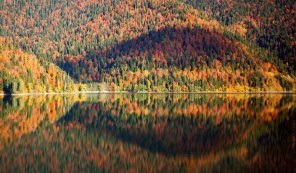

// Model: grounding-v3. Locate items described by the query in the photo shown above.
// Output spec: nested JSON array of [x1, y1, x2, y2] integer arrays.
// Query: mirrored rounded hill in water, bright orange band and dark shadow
[[58, 95, 294, 155]]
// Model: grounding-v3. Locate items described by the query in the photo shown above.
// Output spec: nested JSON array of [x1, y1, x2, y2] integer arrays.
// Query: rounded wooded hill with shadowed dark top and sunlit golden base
[[59, 23, 294, 92]]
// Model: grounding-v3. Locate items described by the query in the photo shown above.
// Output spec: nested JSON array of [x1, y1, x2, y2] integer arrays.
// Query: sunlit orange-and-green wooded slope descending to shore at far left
[[0, 39, 74, 94]]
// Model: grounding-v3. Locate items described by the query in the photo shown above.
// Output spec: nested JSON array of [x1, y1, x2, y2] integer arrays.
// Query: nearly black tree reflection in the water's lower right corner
[[247, 106, 296, 172]]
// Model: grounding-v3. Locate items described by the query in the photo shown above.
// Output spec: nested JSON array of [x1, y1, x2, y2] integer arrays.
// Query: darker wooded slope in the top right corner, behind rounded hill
[[182, 0, 296, 73]]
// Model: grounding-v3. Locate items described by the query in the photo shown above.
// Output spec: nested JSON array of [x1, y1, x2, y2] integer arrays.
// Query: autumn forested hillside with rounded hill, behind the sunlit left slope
[[0, 0, 295, 92]]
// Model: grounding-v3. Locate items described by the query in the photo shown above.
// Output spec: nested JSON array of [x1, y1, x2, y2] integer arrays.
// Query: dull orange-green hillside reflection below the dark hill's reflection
[[0, 125, 245, 172]]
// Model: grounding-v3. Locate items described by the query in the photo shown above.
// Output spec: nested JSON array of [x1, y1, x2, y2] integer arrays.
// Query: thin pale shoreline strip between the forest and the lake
[[0, 91, 296, 96]]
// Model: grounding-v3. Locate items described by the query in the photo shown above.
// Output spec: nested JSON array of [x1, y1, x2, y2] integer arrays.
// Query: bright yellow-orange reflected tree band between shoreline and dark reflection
[[90, 94, 293, 124]]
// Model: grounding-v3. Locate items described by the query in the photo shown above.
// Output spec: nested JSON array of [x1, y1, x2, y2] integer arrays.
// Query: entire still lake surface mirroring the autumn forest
[[0, 94, 296, 172]]
